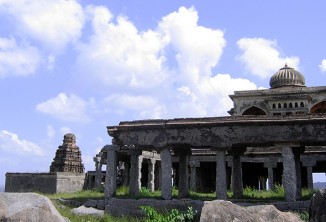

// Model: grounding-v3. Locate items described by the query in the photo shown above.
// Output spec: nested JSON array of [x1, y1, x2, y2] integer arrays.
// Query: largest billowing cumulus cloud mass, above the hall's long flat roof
[[76, 6, 244, 118]]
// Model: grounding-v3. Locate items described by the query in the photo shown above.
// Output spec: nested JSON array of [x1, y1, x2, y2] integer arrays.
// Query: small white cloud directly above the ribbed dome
[[237, 38, 300, 78]]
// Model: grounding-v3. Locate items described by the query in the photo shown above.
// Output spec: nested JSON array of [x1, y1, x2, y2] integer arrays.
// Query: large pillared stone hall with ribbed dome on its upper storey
[[104, 65, 326, 202]]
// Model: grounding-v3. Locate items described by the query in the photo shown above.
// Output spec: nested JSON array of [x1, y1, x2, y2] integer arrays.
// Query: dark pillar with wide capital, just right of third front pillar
[[230, 148, 245, 199]]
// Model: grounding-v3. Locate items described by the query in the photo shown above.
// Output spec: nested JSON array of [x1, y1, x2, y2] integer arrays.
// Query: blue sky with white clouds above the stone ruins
[[0, 0, 326, 185]]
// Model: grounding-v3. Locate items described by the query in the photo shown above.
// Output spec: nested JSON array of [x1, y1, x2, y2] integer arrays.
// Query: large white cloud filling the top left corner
[[0, 0, 84, 51]]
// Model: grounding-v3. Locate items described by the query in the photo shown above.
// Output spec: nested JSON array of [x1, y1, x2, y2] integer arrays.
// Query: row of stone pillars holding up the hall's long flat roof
[[105, 145, 312, 202]]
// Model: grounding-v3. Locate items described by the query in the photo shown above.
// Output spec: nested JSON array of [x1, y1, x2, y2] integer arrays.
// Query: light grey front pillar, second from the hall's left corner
[[160, 147, 172, 200]]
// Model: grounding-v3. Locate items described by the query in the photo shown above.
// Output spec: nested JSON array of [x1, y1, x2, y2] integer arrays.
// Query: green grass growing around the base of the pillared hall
[[43, 186, 316, 222]]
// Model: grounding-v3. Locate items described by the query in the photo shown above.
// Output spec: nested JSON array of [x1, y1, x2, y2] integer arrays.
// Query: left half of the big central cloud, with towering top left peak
[[76, 7, 166, 88]]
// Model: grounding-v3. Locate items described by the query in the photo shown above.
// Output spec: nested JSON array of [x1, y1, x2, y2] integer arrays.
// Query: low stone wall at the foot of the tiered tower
[[5, 172, 85, 193]]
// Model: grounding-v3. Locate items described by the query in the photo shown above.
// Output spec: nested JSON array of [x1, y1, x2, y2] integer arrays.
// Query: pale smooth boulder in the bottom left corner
[[0, 193, 66, 222]]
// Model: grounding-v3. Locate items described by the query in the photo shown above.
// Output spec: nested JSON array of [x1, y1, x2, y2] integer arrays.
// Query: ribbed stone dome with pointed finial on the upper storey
[[269, 64, 305, 88]]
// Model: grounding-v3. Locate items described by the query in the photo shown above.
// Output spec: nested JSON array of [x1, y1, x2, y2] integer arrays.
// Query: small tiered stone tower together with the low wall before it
[[5, 133, 85, 193]]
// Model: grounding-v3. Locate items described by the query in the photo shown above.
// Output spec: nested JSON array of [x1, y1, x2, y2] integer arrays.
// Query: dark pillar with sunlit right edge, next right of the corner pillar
[[129, 150, 143, 195]]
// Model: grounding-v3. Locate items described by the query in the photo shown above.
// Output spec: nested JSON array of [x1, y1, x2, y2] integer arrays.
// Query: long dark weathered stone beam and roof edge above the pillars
[[107, 115, 326, 148]]
